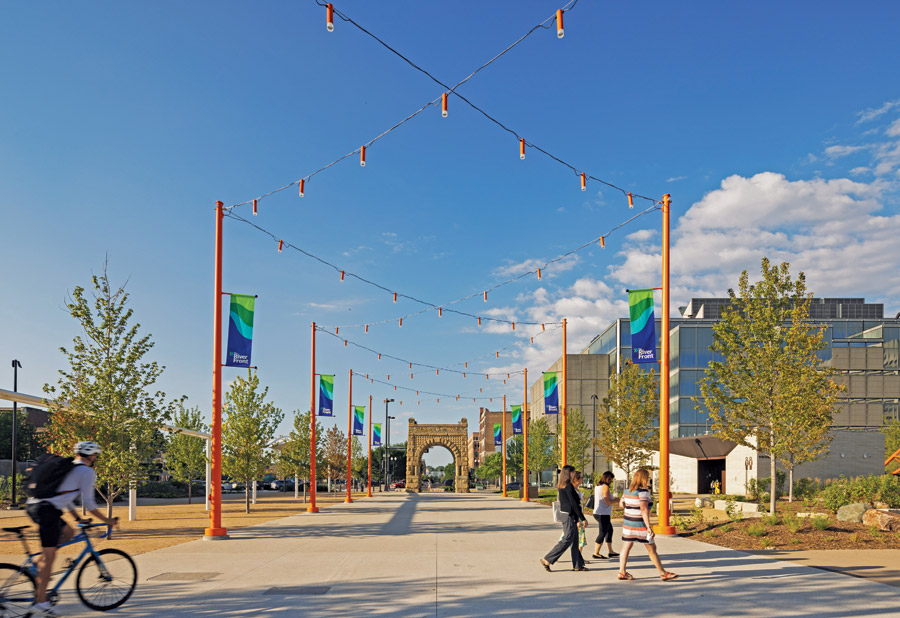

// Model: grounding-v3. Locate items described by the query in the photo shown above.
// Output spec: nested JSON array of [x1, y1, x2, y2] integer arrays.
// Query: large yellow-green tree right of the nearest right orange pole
[[694, 258, 839, 514]]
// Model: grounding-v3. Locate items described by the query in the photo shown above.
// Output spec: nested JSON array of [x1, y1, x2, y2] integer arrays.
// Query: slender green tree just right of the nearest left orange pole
[[222, 369, 284, 513]]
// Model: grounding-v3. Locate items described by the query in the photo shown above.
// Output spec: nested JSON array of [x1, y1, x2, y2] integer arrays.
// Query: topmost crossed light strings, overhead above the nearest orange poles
[[225, 0, 656, 215]]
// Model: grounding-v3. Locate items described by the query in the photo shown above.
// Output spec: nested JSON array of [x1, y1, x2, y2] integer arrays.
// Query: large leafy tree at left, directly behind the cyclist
[[43, 265, 183, 517]]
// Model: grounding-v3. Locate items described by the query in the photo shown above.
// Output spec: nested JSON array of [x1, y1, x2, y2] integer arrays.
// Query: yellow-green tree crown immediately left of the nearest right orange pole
[[596, 363, 659, 481]]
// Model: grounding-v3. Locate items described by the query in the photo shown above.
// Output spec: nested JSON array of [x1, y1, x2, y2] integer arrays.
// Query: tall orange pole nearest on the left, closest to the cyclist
[[203, 202, 228, 539]]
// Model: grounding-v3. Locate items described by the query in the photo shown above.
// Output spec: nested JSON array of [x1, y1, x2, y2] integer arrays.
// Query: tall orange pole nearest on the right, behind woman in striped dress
[[655, 193, 675, 534]]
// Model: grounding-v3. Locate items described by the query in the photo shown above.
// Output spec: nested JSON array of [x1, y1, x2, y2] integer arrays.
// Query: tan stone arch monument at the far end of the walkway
[[406, 418, 469, 493]]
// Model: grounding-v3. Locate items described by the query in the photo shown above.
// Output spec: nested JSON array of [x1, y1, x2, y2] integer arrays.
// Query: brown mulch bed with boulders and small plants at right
[[675, 502, 900, 551]]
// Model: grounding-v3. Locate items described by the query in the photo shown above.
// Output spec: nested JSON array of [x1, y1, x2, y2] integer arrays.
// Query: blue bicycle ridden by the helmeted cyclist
[[0, 523, 137, 618]]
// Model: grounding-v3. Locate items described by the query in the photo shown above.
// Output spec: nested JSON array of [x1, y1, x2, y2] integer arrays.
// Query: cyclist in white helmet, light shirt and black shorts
[[26, 442, 118, 616]]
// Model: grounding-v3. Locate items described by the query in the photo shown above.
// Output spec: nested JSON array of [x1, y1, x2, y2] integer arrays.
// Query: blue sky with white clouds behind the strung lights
[[0, 0, 900, 461]]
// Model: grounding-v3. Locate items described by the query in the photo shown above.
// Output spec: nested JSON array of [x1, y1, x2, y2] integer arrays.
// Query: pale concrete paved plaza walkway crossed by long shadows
[[47, 493, 900, 618]]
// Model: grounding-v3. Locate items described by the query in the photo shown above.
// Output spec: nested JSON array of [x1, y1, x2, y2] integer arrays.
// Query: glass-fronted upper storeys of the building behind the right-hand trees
[[584, 298, 900, 438]]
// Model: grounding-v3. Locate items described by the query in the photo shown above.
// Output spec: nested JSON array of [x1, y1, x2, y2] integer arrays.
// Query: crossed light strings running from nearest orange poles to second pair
[[224, 203, 659, 334]]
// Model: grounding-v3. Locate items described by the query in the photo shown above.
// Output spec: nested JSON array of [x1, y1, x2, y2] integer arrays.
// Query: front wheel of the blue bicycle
[[75, 549, 137, 612]]
